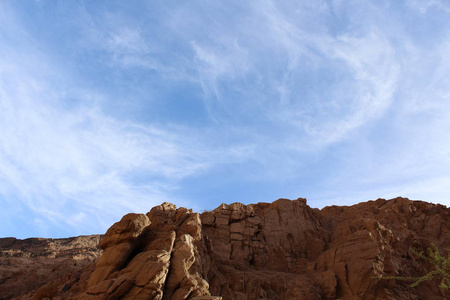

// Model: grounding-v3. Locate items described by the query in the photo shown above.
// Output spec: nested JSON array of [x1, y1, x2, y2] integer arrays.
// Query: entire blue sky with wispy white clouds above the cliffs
[[0, 0, 450, 238]]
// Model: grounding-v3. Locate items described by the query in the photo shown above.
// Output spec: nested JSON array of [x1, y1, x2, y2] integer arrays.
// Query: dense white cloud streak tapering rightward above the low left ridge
[[0, 74, 207, 236]]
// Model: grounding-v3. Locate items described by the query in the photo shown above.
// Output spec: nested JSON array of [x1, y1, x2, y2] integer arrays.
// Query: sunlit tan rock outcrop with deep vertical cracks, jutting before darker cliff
[[77, 203, 210, 300]]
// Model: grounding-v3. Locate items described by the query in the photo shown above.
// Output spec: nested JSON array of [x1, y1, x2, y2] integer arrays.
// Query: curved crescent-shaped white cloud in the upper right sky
[[310, 32, 400, 144]]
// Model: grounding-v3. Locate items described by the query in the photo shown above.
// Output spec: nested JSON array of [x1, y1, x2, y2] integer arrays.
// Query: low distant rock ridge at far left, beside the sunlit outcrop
[[0, 235, 102, 299]]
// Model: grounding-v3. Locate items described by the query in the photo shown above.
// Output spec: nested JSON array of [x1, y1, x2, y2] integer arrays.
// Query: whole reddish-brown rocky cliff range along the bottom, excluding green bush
[[0, 198, 450, 300]]
